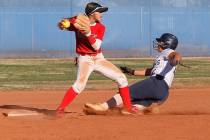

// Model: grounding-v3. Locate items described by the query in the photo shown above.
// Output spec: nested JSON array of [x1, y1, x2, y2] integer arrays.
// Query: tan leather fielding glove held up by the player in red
[[74, 14, 91, 34]]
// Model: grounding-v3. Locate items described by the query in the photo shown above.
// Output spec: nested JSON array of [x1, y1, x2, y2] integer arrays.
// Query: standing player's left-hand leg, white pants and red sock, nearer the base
[[57, 56, 94, 112]]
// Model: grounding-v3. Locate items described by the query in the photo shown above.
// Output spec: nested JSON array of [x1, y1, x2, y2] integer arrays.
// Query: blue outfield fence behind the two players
[[0, 0, 210, 58]]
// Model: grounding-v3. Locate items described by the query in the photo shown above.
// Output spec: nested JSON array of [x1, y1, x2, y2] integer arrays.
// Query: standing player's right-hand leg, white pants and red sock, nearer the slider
[[95, 59, 131, 109]]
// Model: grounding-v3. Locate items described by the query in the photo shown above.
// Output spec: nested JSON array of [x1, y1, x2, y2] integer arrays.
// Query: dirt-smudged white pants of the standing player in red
[[72, 53, 128, 93]]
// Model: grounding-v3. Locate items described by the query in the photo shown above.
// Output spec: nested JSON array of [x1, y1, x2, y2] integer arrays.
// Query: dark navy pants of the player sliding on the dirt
[[129, 77, 169, 107]]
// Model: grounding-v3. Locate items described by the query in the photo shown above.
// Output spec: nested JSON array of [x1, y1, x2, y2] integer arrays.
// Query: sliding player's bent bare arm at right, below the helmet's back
[[168, 51, 182, 66]]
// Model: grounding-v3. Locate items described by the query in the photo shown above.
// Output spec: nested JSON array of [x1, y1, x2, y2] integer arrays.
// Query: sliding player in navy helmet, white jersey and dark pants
[[84, 33, 181, 114]]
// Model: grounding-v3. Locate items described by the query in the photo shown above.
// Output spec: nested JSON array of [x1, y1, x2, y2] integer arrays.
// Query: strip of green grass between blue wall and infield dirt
[[0, 58, 210, 90]]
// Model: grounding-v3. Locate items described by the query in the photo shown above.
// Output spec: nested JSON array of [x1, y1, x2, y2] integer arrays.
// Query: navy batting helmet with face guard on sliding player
[[153, 33, 178, 50]]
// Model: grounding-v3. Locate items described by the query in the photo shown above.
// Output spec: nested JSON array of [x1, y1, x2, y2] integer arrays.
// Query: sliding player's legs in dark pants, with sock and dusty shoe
[[86, 78, 168, 113]]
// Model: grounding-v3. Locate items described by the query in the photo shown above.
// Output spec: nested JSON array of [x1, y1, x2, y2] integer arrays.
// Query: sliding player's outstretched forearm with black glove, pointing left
[[120, 67, 152, 76]]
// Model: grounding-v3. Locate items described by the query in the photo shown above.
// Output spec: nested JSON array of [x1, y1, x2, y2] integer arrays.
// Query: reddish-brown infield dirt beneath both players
[[0, 88, 210, 140]]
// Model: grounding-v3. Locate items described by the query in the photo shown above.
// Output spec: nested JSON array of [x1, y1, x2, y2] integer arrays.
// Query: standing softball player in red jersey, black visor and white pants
[[57, 2, 135, 114]]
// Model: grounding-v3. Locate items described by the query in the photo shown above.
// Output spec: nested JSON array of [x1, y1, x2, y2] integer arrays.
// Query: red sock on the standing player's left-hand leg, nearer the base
[[58, 87, 78, 110]]
